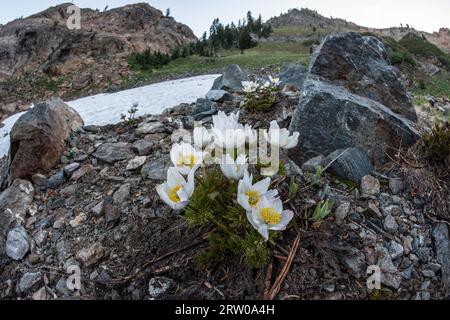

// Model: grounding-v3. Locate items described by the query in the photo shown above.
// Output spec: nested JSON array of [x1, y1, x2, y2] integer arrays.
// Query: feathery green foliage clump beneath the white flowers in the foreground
[[185, 170, 274, 268]]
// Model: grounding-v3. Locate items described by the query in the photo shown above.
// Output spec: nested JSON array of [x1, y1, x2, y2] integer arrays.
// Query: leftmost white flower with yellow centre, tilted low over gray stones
[[156, 167, 195, 210]]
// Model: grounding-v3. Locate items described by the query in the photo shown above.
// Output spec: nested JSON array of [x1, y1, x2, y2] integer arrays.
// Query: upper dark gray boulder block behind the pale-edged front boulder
[[310, 32, 417, 121]]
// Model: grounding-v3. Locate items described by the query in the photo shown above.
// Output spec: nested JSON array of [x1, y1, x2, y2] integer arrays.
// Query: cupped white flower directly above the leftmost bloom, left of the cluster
[[170, 142, 203, 176]]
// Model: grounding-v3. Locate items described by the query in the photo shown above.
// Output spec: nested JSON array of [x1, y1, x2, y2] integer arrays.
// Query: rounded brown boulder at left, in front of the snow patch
[[9, 98, 83, 181]]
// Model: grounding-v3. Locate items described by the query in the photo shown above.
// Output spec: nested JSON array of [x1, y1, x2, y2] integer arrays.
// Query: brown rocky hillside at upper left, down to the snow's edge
[[0, 3, 197, 120]]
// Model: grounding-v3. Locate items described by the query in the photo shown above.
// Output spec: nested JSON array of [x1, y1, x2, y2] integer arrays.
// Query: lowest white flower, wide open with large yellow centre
[[247, 197, 294, 241]]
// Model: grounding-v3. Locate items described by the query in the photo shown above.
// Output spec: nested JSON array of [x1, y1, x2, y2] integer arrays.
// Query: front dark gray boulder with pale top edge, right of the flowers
[[290, 77, 420, 165]]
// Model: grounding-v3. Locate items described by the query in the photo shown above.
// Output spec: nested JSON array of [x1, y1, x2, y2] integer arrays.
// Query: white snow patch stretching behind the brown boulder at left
[[0, 74, 220, 157]]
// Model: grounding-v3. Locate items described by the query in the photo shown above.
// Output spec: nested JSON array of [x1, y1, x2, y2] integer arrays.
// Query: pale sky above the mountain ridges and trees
[[0, 0, 450, 36]]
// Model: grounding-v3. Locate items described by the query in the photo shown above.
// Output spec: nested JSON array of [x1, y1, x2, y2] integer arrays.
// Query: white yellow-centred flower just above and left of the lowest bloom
[[237, 172, 278, 211]]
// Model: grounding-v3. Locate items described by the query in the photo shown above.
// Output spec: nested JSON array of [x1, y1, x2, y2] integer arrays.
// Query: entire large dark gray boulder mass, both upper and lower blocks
[[290, 33, 419, 166]]
